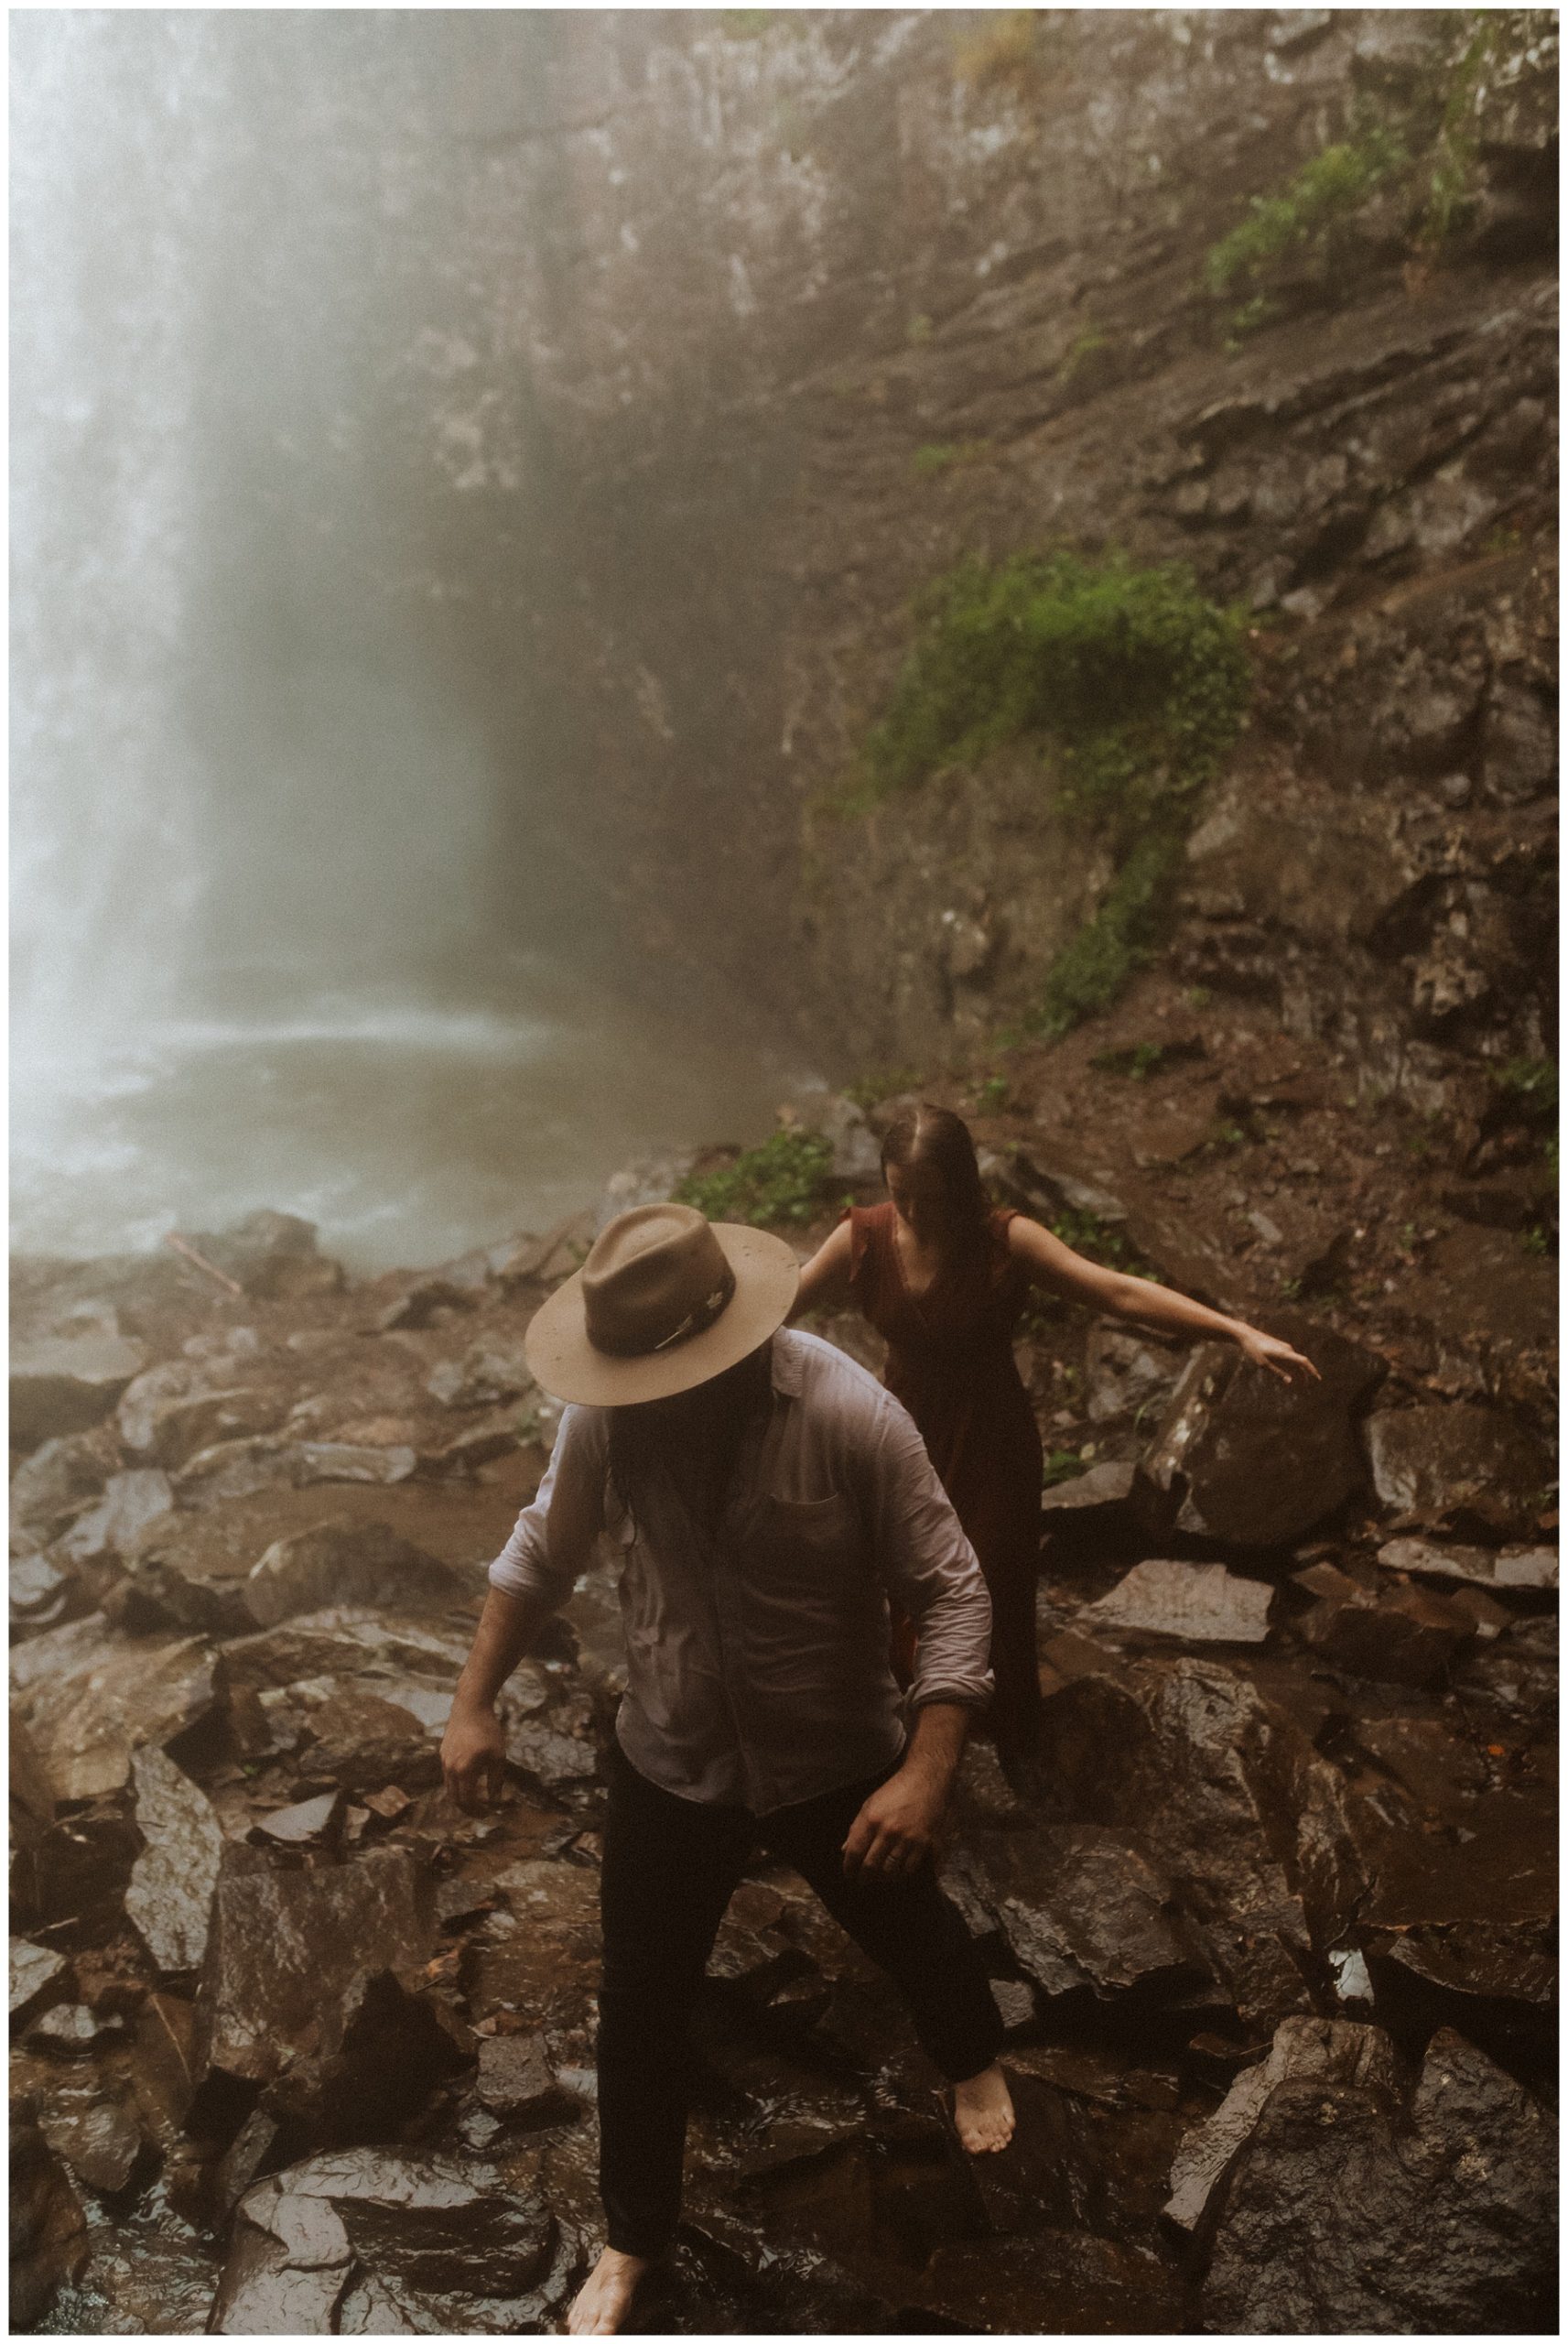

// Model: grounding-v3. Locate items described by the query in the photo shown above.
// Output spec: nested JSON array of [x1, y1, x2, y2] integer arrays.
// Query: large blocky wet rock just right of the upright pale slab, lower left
[[204, 1847, 436, 2081]]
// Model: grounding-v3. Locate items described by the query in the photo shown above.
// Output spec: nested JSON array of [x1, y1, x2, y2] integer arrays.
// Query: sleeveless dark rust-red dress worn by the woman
[[849, 1202, 1043, 1755]]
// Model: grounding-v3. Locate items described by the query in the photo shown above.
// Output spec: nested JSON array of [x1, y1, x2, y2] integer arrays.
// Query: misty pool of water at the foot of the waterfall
[[12, 966, 808, 1271]]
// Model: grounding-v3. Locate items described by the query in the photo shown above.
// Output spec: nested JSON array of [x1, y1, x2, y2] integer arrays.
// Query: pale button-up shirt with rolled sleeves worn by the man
[[490, 1329, 991, 1814]]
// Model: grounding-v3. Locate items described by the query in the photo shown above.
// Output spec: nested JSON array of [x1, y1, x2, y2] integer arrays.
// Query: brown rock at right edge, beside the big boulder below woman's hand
[[1367, 1404, 1552, 1537]]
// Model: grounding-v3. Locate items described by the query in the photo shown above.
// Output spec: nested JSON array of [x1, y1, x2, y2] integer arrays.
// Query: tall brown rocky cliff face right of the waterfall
[[469, 9, 1556, 1104]]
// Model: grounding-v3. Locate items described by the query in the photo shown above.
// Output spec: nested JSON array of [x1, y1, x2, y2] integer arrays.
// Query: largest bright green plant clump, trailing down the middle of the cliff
[[839, 548, 1249, 1036]]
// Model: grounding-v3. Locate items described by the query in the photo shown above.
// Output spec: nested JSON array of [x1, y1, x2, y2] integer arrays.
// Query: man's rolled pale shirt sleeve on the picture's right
[[870, 1399, 996, 1709]]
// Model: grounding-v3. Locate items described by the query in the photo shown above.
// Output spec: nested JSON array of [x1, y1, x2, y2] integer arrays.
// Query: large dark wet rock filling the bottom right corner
[[1203, 2030, 1556, 2335]]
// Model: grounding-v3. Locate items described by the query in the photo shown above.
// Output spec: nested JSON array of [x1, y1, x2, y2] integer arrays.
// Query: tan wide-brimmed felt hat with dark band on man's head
[[523, 1205, 799, 1409]]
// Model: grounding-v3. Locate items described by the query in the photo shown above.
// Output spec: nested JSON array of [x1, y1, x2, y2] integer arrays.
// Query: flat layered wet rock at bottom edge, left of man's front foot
[[211, 2150, 577, 2335]]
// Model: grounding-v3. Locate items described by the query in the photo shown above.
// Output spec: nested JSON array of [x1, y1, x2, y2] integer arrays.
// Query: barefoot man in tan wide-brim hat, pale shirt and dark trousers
[[443, 1205, 1012, 2335]]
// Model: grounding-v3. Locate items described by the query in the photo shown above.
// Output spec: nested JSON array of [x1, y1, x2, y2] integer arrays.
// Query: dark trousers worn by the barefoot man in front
[[598, 1749, 1000, 2255]]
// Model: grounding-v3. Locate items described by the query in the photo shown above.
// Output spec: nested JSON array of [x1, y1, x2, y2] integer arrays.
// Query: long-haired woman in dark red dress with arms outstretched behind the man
[[795, 1101, 1317, 1788]]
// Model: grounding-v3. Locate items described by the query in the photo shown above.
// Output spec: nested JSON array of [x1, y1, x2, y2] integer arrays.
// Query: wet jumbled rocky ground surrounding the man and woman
[[12, 1162, 1556, 2335]]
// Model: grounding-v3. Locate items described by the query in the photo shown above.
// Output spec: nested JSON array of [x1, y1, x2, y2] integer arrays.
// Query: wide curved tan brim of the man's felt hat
[[523, 1221, 799, 1409]]
